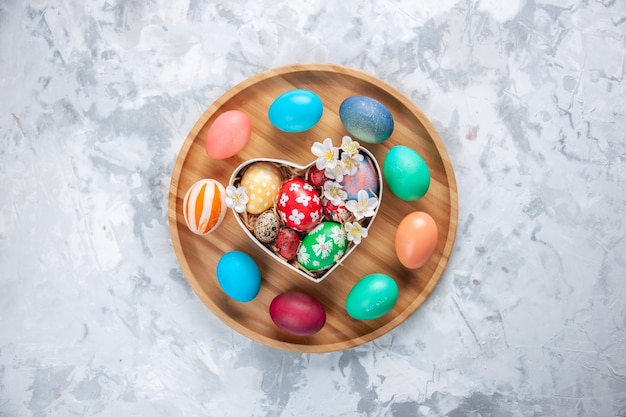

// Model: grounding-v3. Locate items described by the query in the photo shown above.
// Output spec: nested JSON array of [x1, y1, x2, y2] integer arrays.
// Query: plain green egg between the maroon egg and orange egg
[[346, 273, 398, 320]]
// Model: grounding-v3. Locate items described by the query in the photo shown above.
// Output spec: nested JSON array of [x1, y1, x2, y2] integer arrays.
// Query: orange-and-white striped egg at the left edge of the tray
[[183, 179, 226, 235]]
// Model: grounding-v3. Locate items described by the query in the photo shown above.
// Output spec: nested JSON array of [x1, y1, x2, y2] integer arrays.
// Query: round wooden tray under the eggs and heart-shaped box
[[168, 64, 458, 352]]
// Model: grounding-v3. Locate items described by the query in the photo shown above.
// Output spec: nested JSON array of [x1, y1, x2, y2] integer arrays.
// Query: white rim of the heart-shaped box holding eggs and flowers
[[229, 147, 383, 282]]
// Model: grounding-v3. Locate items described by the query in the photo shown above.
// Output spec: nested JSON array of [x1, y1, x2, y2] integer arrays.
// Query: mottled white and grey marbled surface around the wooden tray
[[0, 0, 626, 417]]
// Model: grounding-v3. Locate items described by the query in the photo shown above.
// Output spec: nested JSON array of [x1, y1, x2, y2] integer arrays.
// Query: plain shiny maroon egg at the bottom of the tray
[[270, 291, 326, 336]]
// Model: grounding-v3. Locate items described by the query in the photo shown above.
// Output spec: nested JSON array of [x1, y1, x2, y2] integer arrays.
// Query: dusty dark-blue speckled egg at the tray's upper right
[[339, 96, 394, 143]]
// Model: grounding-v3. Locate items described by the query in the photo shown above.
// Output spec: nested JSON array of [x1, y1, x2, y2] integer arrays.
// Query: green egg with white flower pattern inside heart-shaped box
[[297, 222, 348, 271]]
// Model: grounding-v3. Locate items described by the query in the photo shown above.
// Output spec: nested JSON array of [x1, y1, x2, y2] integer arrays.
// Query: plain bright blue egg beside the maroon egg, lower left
[[217, 251, 261, 302]]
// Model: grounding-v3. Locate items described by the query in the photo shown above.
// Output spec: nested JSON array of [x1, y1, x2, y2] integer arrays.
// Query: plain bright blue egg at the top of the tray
[[268, 90, 324, 132]]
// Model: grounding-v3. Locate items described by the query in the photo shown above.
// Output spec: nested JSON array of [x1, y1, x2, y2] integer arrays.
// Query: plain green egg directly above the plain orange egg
[[383, 145, 430, 201]]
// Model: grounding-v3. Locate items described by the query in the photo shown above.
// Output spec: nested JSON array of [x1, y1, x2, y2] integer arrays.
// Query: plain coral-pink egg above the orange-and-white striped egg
[[206, 110, 252, 159]]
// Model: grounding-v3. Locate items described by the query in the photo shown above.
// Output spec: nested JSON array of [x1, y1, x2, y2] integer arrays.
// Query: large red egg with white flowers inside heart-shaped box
[[277, 178, 322, 232]]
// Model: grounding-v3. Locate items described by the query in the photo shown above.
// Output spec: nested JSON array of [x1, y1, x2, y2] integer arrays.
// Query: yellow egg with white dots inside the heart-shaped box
[[241, 162, 283, 214]]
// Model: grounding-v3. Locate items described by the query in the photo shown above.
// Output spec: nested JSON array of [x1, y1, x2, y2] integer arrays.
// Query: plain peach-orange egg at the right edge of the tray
[[395, 211, 439, 269]]
